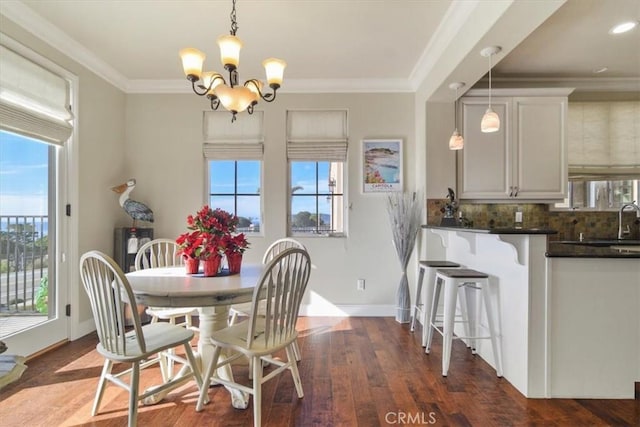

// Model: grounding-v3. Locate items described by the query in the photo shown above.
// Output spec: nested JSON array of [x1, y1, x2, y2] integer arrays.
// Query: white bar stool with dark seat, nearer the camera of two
[[426, 269, 502, 377]]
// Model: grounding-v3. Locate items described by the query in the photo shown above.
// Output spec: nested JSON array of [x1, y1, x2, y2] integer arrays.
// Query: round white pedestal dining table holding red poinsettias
[[126, 263, 264, 409]]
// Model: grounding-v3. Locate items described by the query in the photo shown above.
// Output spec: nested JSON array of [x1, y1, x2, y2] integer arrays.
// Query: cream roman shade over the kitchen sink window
[[568, 101, 640, 179]]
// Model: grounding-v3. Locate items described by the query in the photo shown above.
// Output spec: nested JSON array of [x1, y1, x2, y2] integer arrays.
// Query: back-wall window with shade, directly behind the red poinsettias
[[203, 111, 263, 233]]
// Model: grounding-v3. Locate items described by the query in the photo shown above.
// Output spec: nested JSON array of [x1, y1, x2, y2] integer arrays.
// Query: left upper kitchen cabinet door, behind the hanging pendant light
[[458, 98, 513, 199]]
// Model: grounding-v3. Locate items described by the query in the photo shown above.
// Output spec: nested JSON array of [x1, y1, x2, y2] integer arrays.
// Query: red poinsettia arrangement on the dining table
[[176, 205, 249, 273]]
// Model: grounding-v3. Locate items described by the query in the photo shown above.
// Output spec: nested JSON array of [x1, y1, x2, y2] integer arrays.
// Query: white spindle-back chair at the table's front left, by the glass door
[[80, 251, 202, 426]]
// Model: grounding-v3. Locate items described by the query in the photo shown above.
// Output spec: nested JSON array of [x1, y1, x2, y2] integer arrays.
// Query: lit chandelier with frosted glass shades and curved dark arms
[[180, 0, 287, 122]]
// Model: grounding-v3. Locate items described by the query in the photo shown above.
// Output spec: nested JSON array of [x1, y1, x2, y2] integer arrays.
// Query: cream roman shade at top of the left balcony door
[[0, 45, 73, 145]]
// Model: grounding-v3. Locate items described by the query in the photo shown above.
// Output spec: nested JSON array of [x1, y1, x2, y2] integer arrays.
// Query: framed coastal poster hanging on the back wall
[[362, 139, 403, 193]]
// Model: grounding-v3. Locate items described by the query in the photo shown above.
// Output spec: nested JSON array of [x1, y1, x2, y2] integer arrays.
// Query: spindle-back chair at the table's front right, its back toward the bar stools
[[196, 248, 311, 426]]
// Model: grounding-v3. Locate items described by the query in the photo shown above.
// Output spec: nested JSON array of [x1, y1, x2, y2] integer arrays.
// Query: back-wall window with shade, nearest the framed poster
[[287, 110, 347, 236]]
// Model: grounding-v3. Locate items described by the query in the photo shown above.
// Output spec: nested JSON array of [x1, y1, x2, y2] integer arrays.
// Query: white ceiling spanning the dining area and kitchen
[[0, 0, 640, 98]]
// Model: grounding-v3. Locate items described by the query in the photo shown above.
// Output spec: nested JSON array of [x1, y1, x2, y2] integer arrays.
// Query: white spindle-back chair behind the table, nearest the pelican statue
[[134, 239, 197, 329]]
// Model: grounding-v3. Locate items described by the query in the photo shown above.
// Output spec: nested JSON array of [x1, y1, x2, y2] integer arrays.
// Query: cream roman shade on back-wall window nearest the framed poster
[[287, 110, 348, 162]]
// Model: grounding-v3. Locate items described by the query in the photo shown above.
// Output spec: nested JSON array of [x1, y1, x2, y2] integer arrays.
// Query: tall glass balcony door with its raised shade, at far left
[[0, 35, 78, 354]]
